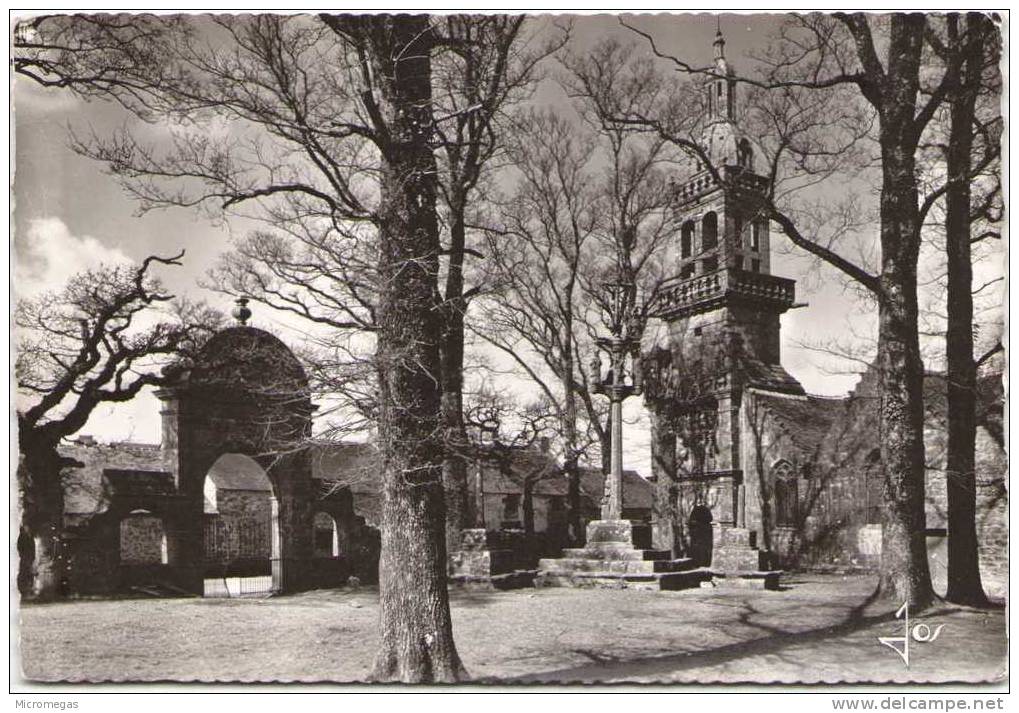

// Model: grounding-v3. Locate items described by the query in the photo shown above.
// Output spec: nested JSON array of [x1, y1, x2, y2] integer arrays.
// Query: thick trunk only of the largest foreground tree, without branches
[[369, 15, 467, 682]]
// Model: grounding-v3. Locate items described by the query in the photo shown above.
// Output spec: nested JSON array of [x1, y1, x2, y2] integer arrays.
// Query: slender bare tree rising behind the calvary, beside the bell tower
[[564, 40, 680, 474]]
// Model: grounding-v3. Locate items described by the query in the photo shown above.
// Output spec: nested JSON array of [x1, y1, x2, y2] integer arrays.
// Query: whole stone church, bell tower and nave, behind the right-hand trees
[[642, 27, 1007, 595]]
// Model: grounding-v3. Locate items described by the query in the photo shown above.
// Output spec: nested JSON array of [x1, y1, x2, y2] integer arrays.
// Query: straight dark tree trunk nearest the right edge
[[945, 18, 987, 606]]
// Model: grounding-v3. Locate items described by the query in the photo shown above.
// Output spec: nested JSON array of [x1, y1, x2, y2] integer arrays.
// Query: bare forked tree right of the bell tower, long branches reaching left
[[621, 13, 978, 607]]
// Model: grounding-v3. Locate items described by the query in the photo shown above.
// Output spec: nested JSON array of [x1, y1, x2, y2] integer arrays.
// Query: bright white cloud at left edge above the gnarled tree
[[14, 217, 130, 296]]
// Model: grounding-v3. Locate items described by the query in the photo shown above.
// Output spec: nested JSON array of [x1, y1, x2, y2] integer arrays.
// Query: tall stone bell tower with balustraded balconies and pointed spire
[[645, 31, 804, 527]]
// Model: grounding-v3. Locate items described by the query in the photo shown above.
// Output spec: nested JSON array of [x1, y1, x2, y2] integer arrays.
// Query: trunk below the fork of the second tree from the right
[[877, 114, 931, 610]]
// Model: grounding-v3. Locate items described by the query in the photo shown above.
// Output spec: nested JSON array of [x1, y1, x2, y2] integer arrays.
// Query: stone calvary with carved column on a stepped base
[[534, 283, 711, 590]]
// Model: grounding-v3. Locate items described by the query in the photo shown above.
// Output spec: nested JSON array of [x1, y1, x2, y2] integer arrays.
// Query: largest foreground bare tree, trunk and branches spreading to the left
[[14, 9, 476, 681]]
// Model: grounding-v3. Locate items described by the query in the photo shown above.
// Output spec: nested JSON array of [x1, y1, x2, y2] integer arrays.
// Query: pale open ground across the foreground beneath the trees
[[19, 575, 1007, 683]]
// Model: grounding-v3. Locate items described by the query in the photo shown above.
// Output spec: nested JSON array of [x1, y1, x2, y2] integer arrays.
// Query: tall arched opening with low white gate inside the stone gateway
[[202, 453, 281, 597]]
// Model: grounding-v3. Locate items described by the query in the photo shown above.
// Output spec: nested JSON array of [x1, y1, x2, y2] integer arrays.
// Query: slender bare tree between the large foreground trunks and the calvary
[[479, 111, 598, 542]]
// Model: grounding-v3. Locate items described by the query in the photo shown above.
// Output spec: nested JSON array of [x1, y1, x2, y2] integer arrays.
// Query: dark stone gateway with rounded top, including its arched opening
[[157, 324, 313, 596]]
